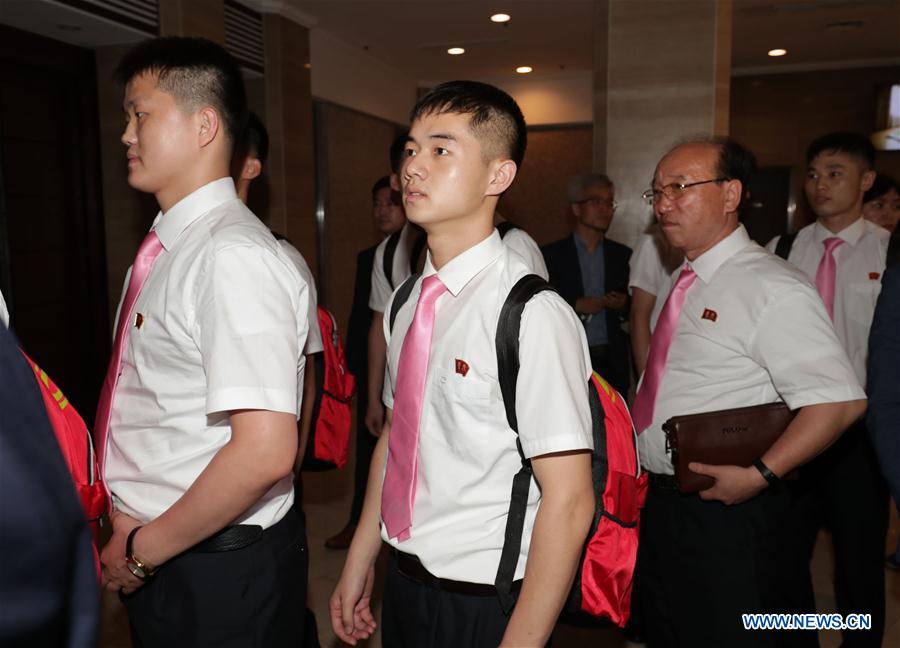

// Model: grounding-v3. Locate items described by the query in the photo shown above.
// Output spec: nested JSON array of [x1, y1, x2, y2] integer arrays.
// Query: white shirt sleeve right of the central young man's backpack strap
[[516, 292, 593, 458]]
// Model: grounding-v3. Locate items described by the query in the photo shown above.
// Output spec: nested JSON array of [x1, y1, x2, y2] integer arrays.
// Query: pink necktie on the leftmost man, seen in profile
[[94, 230, 163, 468]]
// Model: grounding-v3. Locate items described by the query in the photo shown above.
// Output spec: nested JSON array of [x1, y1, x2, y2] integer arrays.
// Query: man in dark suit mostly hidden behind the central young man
[[325, 176, 406, 549]]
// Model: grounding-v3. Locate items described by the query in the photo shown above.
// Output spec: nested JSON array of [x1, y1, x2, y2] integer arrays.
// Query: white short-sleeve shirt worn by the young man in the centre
[[382, 231, 593, 583]]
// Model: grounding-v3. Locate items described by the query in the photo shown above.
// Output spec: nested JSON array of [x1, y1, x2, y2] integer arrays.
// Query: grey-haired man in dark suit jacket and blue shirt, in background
[[542, 174, 631, 395]]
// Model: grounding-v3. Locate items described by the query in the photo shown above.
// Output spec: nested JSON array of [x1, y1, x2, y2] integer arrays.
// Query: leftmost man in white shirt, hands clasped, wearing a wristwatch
[[95, 38, 309, 648]]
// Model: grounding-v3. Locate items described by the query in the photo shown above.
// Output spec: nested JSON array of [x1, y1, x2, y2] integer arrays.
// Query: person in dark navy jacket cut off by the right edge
[[866, 260, 900, 569]]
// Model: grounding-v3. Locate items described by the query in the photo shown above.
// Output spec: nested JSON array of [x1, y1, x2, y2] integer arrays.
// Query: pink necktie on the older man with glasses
[[631, 265, 697, 434]]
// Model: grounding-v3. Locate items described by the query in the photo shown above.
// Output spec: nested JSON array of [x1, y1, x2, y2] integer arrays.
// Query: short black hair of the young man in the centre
[[410, 81, 528, 167]]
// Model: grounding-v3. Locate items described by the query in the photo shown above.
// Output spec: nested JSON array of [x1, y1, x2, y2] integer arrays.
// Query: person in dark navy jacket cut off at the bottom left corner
[[0, 316, 100, 648]]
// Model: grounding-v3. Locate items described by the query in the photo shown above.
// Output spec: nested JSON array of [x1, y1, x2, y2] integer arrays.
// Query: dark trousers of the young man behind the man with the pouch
[[791, 423, 888, 648]]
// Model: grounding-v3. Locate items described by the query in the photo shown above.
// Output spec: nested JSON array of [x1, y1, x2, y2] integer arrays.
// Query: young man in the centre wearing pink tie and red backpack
[[331, 81, 594, 647]]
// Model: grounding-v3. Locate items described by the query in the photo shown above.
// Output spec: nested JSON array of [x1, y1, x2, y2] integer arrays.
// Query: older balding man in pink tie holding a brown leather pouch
[[632, 139, 866, 648]]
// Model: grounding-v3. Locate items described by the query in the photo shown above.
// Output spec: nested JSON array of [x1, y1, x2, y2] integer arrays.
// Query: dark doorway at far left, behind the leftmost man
[[0, 26, 110, 422]]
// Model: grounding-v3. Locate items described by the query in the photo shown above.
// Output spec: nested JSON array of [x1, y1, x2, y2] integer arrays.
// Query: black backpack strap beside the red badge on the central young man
[[494, 274, 553, 614]]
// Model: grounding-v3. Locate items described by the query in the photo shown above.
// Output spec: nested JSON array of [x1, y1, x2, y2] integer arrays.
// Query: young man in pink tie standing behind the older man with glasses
[[768, 133, 890, 646]]
